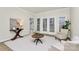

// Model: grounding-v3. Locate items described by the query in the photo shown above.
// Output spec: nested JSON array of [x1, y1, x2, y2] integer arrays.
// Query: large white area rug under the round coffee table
[[5, 35, 59, 51]]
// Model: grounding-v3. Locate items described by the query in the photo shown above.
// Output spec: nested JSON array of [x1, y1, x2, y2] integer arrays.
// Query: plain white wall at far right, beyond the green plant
[[71, 7, 79, 40]]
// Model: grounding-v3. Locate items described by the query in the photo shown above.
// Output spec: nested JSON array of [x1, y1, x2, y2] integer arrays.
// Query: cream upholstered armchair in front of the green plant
[[55, 29, 68, 41]]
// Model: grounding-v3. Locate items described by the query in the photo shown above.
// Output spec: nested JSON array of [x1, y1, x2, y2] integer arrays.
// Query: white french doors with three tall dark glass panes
[[37, 17, 55, 34]]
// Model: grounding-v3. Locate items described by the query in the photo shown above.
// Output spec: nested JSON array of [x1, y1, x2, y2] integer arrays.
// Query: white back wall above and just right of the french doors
[[35, 8, 70, 32]]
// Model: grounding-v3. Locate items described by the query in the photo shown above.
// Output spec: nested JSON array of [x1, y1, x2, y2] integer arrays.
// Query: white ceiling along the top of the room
[[20, 7, 64, 13]]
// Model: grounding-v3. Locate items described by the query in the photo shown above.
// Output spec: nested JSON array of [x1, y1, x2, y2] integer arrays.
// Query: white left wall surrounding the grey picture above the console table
[[0, 7, 33, 40]]
